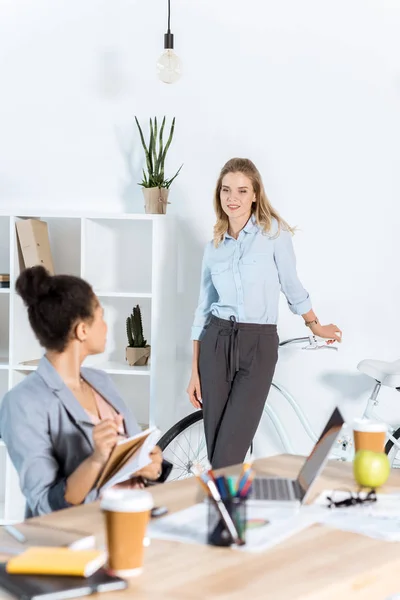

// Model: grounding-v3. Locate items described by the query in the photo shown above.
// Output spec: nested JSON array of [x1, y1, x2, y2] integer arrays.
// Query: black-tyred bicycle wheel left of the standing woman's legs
[[158, 410, 208, 481]]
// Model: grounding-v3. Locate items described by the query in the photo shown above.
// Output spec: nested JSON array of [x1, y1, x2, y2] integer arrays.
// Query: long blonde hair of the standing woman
[[214, 158, 294, 248]]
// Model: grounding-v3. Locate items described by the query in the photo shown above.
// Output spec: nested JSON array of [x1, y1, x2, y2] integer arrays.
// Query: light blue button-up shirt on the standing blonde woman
[[191, 217, 311, 340]]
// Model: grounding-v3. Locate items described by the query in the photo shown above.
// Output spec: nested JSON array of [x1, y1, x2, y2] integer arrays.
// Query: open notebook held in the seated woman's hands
[[96, 427, 160, 489]]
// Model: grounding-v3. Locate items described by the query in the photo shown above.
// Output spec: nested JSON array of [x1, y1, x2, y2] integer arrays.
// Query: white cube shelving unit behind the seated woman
[[0, 211, 177, 523]]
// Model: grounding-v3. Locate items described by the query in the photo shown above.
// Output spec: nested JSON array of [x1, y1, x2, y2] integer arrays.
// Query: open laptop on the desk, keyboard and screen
[[249, 408, 344, 504]]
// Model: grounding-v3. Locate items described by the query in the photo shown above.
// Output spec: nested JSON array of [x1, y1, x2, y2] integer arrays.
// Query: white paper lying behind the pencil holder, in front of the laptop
[[148, 502, 321, 552]]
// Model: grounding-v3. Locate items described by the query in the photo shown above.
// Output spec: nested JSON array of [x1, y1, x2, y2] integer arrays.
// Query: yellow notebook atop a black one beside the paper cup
[[6, 546, 107, 577]]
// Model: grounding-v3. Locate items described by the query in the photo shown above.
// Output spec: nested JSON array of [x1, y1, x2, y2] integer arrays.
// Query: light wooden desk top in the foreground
[[0, 455, 400, 600]]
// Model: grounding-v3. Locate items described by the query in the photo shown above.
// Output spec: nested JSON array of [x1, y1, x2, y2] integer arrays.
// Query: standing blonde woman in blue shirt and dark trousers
[[187, 158, 341, 469]]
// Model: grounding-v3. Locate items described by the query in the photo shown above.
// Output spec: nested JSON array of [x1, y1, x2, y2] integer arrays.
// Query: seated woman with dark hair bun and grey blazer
[[0, 266, 171, 517]]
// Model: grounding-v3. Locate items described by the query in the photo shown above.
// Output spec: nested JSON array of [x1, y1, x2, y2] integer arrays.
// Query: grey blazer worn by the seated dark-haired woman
[[0, 356, 140, 518]]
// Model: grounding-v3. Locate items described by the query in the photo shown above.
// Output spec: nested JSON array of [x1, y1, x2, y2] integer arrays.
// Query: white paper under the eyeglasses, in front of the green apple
[[316, 490, 400, 542]]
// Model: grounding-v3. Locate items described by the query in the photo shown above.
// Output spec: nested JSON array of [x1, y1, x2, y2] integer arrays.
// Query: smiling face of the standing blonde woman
[[220, 173, 256, 219]]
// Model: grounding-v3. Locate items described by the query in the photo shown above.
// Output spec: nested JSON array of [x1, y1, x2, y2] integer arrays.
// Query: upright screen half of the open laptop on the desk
[[297, 408, 344, 500]]
